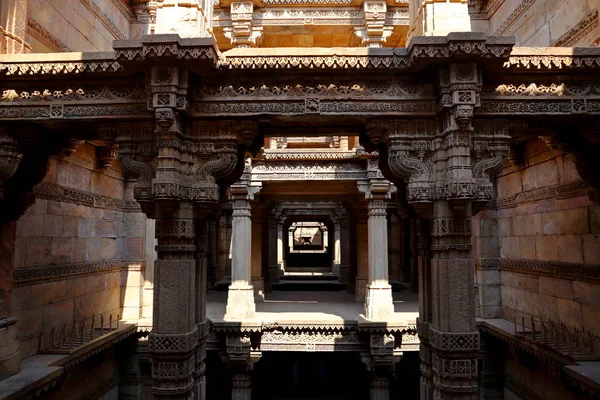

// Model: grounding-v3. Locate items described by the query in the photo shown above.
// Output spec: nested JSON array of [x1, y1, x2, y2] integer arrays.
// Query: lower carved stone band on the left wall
[[13, 259, 145, 287]]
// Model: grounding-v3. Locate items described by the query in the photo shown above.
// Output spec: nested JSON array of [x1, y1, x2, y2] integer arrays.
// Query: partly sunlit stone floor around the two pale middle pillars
[[207, 291, 419, 325]]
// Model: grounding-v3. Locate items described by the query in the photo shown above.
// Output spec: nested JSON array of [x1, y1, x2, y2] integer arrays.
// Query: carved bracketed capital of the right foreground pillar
[[368, 117, 513, 214]]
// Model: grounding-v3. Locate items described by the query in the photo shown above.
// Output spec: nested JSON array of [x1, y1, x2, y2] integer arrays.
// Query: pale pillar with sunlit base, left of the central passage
[[225, 184, 256, 319]]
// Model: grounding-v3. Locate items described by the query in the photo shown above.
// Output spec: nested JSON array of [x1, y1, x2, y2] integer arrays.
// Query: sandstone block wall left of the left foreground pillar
[[12, 143, 146, 358]]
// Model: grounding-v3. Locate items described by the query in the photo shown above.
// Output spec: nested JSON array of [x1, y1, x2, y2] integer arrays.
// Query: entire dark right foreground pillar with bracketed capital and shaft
[[369, 67, 511, 399]]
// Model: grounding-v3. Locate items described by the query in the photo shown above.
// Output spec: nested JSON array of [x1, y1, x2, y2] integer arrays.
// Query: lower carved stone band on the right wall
[[475, 258, 600, 284]]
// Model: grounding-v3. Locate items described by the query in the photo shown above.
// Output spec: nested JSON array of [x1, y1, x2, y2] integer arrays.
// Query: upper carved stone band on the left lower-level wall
[[33, 183, 141, 212]]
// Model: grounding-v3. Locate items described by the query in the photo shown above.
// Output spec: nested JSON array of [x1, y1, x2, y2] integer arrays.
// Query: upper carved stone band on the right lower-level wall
[[496, 181, 591, 209]]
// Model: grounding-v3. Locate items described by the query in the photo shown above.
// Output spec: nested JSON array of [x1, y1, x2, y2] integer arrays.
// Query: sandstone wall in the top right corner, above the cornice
[[482, 0, 600, 47]]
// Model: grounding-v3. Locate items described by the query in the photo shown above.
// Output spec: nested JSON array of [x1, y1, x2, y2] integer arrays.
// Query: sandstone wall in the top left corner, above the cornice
[[26, 0, 133, 53]]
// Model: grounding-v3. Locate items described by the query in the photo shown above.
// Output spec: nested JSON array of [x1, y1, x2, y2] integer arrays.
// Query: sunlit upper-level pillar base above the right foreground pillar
[[407, 0, 471, 43]]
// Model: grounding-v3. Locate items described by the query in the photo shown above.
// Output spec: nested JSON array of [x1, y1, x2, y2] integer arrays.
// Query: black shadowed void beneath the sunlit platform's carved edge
[[207, 352, 419, 400]]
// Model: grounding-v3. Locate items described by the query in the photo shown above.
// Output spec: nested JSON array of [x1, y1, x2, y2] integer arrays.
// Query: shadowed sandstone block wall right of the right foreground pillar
[[474, 139, 600, 334]]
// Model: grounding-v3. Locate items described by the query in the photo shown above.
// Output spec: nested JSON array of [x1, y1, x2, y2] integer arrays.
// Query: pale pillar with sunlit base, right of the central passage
[[359, 179, 395, 320]]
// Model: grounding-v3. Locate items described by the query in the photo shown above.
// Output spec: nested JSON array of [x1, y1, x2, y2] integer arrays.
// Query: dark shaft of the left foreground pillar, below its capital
[[149, 205, 206, 399]]
